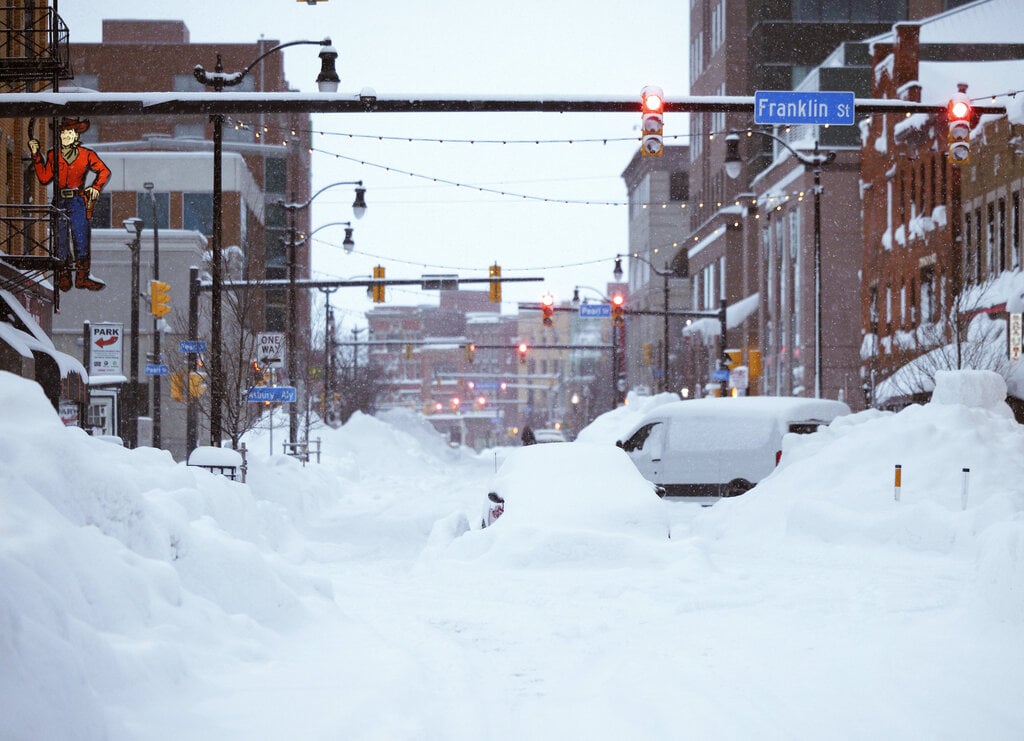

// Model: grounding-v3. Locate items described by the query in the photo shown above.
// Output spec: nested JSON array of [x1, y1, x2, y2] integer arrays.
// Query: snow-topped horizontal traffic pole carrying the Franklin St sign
[[0, 92, 1007, 118]]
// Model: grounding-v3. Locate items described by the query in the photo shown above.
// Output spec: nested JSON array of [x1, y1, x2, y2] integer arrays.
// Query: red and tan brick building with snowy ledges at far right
[[860, 0, 1024, 404]]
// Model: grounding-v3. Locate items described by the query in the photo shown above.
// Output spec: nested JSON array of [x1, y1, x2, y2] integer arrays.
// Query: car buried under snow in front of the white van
[[480, 442, 669, 537]]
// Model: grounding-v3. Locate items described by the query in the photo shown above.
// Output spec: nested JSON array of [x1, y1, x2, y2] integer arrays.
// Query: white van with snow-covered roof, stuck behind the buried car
[[615, 396, 850, 496]]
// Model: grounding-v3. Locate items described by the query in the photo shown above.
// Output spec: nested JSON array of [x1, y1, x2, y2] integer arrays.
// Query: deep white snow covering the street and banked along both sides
[[0, 374, 1024, 740]]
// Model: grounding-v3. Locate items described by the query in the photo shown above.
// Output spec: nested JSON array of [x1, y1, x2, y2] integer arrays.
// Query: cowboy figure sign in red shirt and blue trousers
[[29, 119, 111, 291]]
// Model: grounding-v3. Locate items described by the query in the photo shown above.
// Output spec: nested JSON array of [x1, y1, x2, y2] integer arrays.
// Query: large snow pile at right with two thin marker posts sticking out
[[700, 371, 1024, 622]]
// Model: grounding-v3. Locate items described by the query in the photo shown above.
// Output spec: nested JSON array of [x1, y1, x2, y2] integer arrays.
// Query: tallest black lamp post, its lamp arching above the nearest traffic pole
[[193, 38, 340, 446]]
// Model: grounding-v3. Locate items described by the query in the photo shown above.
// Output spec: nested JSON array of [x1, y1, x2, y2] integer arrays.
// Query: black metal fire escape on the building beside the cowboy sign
[[0, 0, 73, 302]]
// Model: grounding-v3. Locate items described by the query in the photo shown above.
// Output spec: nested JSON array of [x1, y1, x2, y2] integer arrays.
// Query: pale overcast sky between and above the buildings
[[58, 0, 688, 325]]
